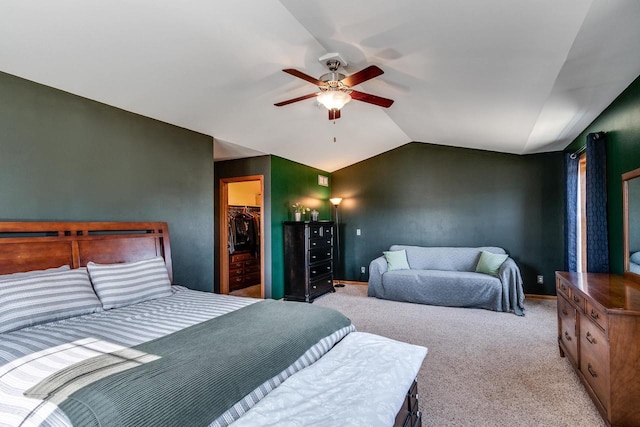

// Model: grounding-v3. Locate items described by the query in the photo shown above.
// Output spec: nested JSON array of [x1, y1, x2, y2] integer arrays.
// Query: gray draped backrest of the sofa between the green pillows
[[390, 245, 505, 272]]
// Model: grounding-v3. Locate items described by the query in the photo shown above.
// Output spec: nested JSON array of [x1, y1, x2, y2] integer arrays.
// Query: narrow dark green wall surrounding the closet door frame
[[214, 156, 272, 298]]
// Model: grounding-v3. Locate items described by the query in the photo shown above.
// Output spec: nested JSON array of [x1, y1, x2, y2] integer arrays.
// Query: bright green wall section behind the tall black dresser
[[271, 156, 331, 298]]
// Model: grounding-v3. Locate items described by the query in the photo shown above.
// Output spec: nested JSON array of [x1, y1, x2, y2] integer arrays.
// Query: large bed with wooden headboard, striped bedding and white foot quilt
[[0, 222, 427, 427]]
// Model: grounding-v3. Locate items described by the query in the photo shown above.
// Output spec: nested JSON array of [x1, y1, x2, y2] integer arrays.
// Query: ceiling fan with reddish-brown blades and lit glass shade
[[274, 53, 393, 120]]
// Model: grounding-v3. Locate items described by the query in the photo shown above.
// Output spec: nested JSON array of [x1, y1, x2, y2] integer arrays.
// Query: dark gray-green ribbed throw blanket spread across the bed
[[25, 300, 351, 426]]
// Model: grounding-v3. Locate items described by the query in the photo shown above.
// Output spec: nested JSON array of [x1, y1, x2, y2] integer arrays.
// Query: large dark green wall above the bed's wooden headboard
[[0, 73, 213, 291]]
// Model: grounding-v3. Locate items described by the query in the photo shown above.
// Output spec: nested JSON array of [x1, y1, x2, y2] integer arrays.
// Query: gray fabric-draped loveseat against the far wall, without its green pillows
[[368, 245, 524, 316]]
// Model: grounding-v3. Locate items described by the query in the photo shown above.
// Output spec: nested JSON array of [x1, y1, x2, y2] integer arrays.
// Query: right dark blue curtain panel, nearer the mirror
[[586, 132, 609, 273]]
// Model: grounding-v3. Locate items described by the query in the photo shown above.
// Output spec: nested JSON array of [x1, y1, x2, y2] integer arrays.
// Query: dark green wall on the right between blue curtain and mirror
[[566, 77, 640, 273]]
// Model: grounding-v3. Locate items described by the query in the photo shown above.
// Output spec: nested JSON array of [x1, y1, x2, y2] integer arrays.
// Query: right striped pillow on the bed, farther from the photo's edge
[[87, 257, 172, 310]]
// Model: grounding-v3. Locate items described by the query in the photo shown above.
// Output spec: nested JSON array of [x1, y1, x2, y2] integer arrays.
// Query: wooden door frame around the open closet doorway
[[218, 175, 265, 299]]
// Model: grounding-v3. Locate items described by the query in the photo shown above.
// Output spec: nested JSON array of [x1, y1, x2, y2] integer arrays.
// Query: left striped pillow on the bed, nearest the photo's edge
[[0, 268, 102, 333]]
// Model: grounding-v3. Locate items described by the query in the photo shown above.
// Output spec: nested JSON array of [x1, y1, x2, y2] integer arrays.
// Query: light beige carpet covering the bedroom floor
[[314, 285, 605, 427]]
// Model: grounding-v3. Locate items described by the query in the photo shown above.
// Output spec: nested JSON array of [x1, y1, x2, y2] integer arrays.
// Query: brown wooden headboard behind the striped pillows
[[0, 222, 173, 283]]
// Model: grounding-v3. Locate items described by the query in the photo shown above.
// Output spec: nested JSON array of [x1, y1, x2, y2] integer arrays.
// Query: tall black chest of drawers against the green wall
[[284, 221, 335, 302]]
